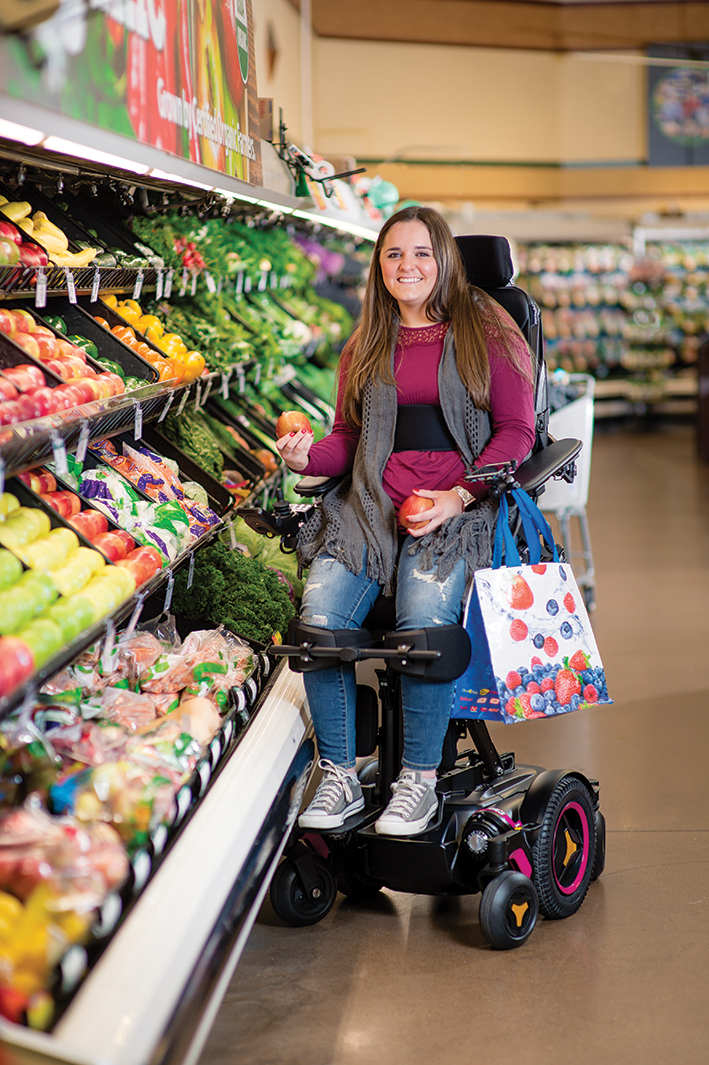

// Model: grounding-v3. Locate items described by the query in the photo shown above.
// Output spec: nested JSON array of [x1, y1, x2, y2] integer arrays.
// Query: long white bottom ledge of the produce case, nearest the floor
[[0, 663, 314, 1065]]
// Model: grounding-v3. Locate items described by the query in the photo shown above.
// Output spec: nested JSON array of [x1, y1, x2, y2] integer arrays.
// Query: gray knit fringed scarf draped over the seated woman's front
[[298, 330, 497, 595]]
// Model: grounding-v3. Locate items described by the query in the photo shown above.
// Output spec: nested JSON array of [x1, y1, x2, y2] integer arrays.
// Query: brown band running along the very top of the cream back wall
[[291, 0, 709, 51]]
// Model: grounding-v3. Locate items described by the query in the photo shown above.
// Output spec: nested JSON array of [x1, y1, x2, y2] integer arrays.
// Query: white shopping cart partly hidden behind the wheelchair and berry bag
[[539, 372, 596, 610]]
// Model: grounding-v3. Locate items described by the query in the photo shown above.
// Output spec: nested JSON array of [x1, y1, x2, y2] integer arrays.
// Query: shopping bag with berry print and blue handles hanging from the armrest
[[451, 489, 612, 724]]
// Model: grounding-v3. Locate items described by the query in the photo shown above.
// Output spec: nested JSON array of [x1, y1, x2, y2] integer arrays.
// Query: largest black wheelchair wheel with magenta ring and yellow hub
[[532, 776, 596, 920]]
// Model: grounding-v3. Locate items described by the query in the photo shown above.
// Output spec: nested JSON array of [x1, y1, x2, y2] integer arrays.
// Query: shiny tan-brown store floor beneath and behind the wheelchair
[[201, 428, 709, 1065]]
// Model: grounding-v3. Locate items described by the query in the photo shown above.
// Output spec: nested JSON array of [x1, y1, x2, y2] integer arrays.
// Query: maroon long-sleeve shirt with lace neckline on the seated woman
[[302, 315, 534, 510]]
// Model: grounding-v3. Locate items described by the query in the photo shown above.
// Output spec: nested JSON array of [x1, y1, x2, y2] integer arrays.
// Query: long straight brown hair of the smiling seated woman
[[343, 207, 530, 427]]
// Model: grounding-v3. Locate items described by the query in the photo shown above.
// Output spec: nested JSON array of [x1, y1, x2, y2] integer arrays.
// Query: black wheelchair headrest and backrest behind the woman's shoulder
[[456, 233, 549, 452]]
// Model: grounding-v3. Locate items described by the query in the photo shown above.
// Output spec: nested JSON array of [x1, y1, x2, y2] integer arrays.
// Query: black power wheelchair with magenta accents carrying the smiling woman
[[242, 236, 605, 950]]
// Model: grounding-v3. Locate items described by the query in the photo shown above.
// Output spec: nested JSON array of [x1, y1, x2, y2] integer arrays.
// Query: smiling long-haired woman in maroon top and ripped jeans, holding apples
[[271, 206, 534, 836]]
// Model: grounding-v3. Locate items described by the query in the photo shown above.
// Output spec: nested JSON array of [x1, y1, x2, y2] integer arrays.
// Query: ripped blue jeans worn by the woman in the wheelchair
[[300, 537, 465, 770]]
